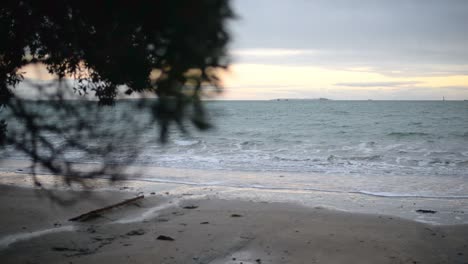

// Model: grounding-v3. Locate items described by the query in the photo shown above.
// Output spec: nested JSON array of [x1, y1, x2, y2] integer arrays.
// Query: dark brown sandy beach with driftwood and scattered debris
[[0, 182, 468, 264]]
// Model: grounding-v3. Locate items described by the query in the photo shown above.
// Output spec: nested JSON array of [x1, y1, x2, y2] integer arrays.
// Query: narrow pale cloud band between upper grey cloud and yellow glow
[[230, 48, 468, 77]]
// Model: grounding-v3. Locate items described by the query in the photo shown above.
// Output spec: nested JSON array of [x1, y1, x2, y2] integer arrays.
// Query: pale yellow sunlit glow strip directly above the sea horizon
[[222, 64, 468, 100]]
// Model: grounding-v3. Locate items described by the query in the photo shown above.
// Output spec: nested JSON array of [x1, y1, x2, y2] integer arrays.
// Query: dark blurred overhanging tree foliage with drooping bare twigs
[[0, 0, 234, 198]]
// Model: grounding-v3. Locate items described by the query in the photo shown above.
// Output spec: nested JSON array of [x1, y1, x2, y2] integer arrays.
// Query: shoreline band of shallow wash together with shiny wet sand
[[0, 160, 468, 225]]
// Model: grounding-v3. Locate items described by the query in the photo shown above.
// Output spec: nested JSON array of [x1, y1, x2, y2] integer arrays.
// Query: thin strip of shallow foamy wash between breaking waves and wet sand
[[0, 159, 468, 199]]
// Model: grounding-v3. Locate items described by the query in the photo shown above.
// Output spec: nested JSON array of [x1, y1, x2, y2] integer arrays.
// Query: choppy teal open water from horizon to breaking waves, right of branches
[[161, 101, 468, 177]]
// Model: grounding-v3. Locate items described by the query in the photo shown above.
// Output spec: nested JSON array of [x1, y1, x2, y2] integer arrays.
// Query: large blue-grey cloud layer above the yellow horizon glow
[[231, 0, 468, 76]]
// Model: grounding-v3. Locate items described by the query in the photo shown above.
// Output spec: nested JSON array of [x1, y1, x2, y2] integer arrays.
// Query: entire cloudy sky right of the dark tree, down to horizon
[[222, 0, 468, 100]]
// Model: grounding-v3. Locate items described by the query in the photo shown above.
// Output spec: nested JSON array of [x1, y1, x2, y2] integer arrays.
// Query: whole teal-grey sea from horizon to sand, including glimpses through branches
[[0, 100, 468, 224]]
